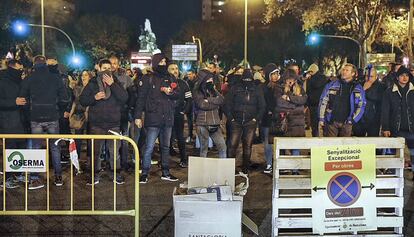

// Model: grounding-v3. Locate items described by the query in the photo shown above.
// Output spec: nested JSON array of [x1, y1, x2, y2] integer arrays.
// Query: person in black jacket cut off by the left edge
[[0, 60, 27, 188]]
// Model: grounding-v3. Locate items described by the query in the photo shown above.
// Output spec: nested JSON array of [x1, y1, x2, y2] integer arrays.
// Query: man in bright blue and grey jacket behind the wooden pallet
[[318, 63, 366, 137]]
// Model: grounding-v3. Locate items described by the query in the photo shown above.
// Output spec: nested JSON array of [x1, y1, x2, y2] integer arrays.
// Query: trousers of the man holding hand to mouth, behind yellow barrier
[[90, 126, 121, 174]]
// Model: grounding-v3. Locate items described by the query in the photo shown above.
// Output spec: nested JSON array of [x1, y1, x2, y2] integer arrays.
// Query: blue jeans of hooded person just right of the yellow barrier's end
[[142, 126, 172, 176]]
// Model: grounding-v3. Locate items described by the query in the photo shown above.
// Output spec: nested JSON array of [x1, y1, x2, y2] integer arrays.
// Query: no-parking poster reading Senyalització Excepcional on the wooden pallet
[[311, 145, 377, 234]]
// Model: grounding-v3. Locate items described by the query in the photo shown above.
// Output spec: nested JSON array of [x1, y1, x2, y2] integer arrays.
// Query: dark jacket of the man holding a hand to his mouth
[[79, 76, 128, 129]]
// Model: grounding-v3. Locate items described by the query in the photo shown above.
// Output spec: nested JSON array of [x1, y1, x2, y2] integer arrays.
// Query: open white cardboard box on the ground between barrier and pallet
[[173, 157, 243, 237]]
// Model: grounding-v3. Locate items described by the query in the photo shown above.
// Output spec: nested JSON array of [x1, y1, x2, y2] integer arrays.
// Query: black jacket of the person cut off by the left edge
[[0, 68, 24, 134]]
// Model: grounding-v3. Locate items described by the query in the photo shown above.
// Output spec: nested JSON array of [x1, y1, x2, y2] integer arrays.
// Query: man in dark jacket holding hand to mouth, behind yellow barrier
[[79, 59, 128, 185]]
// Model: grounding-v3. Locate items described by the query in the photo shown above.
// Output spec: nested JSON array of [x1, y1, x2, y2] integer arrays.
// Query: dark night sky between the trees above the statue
[[76, 0, 201, 46]]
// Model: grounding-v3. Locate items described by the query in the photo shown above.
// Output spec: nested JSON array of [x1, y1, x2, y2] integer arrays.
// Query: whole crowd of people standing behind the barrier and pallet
[[0, 53, 414, 189]]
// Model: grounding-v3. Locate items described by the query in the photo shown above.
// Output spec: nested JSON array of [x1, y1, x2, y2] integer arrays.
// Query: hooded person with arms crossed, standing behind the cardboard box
[[193, 69, 227, 158]]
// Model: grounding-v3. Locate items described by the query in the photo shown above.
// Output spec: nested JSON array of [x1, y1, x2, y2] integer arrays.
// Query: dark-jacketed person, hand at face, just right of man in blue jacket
[[352, 67, 385, 137]]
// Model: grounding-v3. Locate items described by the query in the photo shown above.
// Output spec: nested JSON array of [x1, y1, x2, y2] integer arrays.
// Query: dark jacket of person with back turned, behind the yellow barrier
[[20, 65, 71, 122]]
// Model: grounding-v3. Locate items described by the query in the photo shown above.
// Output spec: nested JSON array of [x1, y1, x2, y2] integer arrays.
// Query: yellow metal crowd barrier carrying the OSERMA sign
[[0, 134, 139, 237]]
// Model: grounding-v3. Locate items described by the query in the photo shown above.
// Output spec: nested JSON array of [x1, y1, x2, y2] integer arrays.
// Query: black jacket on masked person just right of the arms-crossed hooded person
[[225, 83, 266, 124]]
